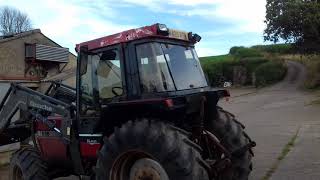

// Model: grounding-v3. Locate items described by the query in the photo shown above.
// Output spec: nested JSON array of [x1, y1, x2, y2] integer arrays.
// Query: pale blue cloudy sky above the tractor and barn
[[0, 0, 266, 56]]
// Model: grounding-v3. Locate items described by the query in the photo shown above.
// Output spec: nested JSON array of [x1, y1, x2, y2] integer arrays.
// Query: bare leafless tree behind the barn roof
[[0, 6, 31, 35]]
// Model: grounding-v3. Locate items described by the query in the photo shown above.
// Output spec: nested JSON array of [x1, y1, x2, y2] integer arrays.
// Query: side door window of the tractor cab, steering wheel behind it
[[80, 49, 123, 114]]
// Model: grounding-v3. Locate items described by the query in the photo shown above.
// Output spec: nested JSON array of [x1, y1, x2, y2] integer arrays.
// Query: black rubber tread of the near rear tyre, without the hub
[[96, 119, 208, 180]]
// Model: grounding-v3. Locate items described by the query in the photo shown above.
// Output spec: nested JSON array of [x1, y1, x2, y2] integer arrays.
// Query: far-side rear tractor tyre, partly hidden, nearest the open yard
[[208, 107, 253, 180]]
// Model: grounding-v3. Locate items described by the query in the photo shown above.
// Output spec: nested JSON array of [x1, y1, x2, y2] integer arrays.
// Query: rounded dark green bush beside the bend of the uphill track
[[255, 61, 287, 87]]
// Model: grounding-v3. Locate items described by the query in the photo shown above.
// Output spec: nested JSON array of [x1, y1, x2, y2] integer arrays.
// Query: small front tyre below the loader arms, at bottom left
[[9, 148, 49, 180]]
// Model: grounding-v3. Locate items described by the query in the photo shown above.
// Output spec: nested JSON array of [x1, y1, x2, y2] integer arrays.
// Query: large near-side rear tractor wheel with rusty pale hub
[[96, 120, 208, 180]]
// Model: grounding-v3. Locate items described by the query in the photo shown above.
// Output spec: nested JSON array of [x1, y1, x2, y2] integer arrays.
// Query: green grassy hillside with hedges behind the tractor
[[200, 44, 320, 89]]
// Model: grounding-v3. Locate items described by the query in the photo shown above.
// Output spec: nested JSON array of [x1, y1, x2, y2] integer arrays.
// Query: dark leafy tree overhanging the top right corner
[[264, 0, 320, 52]]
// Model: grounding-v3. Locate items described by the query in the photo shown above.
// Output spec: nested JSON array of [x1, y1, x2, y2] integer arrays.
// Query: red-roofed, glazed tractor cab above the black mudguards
[[76, 24, 208, 103]]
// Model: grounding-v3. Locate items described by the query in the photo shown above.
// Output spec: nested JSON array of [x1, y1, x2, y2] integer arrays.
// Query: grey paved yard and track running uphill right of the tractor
[[220, 61, 320, 180]]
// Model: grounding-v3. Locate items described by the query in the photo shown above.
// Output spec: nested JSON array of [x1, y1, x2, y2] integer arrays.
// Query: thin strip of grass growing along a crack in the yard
[[262, 127, 300, 180]]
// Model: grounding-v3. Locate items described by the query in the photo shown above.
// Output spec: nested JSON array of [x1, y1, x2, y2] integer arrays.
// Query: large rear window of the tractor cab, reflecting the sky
[[136, 42, 207, 92]]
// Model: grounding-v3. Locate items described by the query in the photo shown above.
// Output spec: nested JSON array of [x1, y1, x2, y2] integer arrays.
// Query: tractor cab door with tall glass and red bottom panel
[[77, 45, 126, 159]]
